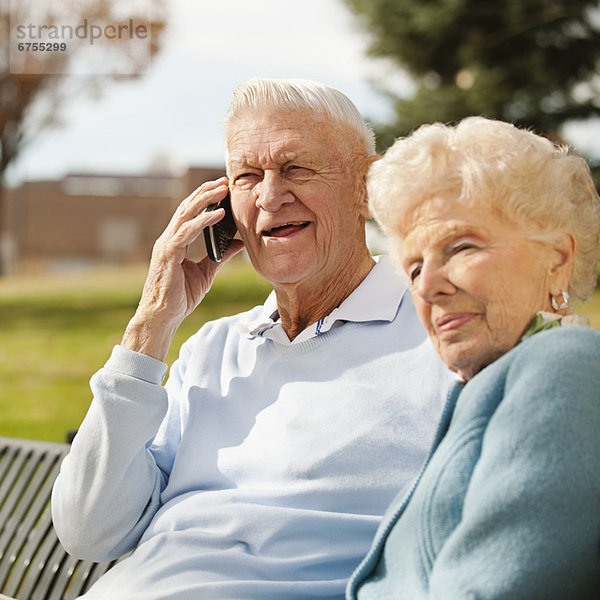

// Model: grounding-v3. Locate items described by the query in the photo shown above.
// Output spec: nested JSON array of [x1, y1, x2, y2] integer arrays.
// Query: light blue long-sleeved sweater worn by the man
[[53, 258, 448, 600]]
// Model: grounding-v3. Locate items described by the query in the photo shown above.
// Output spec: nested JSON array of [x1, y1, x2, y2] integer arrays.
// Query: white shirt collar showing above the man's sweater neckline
[[238, 255, 408, 345]]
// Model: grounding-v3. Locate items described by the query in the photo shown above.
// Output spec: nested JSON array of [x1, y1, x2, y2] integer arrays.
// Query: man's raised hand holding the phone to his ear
[[121, 177, 243, 360]]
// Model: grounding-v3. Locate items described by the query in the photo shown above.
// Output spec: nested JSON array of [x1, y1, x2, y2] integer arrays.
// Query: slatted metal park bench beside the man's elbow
[[0, 437, 122, 600]]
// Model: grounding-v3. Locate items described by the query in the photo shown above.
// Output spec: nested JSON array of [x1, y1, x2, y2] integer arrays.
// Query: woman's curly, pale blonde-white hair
[[367, 117, 600, 302]]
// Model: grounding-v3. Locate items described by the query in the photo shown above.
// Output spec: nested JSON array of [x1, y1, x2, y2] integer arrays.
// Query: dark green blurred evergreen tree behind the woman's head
[[345, 0, 600, 148]]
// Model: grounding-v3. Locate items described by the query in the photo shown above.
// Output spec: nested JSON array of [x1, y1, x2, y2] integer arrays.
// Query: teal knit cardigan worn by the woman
[[347, 327, 600, 600]]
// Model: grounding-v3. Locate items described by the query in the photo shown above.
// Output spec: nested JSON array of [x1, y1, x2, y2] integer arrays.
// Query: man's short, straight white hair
[[225, 78, 375, 156]]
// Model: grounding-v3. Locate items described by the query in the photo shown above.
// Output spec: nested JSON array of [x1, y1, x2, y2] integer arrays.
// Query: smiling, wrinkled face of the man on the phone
[[227, 109, 367, 287]]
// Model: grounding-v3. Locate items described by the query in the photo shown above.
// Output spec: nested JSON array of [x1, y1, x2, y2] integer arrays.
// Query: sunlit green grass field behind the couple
[[0, 259, 600, 441]]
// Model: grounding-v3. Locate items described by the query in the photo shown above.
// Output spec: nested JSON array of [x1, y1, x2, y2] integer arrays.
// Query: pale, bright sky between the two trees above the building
[[7, 0, 410, 185]]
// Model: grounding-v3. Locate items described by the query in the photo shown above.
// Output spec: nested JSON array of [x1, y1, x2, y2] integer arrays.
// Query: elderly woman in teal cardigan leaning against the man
[[347, 117, 600, 600]]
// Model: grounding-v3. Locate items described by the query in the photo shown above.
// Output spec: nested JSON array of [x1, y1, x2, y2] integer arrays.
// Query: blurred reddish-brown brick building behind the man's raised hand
[[0, 168, 224, 272]]
